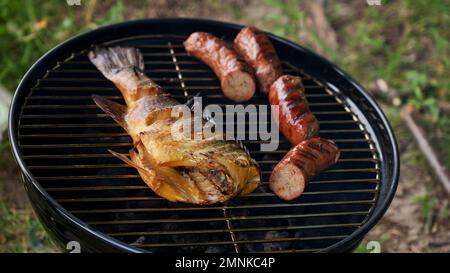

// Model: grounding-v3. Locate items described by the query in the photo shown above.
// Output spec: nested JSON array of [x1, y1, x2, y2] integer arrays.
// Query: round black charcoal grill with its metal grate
[[10, 19, 399, 253]]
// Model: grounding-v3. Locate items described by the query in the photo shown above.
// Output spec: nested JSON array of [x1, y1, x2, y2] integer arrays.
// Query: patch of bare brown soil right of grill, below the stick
[[362, 105, 450, 252]]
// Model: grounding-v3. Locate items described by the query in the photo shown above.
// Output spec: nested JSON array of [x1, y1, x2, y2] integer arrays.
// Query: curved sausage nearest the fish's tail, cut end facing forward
[[184, 32, 256, 102]]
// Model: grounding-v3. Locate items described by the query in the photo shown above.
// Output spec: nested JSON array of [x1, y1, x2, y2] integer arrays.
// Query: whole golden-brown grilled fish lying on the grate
[[88, 47, 261, 205]]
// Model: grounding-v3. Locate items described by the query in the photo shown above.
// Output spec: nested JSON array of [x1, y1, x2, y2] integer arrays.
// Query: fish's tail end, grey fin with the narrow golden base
[[88, 46, 164, 108]]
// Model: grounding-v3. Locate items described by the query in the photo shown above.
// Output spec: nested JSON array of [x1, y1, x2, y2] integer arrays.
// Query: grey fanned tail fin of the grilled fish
[[88, 46, 144, 82]]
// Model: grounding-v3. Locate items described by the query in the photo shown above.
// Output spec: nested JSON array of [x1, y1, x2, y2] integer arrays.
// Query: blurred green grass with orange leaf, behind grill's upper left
[[0, 0, 137, 90]]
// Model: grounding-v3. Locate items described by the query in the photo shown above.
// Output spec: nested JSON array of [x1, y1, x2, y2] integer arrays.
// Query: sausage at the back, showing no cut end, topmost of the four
[[233, 27, 283, 94]]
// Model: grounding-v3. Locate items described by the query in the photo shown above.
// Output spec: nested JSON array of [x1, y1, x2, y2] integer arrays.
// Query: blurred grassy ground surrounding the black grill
[[0, 0, 450, 252]]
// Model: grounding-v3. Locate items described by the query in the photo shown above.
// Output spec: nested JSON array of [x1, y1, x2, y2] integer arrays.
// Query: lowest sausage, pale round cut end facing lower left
[[269, 137, 339, 201]]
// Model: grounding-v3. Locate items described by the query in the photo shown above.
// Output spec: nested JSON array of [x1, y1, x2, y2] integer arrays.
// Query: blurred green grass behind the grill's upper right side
[[265, 0, 450, 166]]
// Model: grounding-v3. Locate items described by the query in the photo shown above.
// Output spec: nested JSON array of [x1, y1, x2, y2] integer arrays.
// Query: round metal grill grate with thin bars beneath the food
[[18, 35, 380, 252]]
